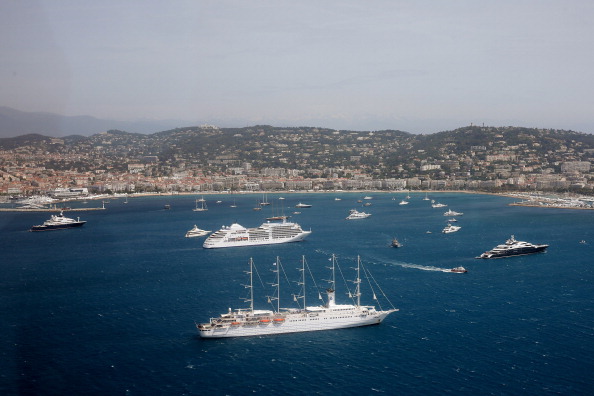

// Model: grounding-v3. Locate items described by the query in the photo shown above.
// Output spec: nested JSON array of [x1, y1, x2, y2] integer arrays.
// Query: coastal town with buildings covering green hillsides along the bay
[[0, 125, 594, 207]]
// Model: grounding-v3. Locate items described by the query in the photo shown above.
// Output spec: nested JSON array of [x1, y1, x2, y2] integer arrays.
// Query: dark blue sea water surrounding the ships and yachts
[[0, 193, 594, 395]]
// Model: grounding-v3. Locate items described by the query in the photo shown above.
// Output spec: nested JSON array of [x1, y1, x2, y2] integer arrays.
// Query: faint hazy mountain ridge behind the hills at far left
[[0, 106, 192, 138]]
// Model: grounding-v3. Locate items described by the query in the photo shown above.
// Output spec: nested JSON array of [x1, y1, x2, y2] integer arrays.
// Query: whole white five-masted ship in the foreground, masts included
[[196, 256, 398, 338]]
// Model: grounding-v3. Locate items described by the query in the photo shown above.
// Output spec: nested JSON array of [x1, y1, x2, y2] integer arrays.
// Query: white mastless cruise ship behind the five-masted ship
[[202, 220, 311, 249]]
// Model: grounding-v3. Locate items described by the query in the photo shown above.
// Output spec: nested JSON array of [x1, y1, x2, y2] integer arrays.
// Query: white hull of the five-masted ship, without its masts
[[197, 310, 396, 338]]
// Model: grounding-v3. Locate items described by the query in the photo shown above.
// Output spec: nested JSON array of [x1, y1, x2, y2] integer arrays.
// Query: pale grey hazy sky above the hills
[[0, 0, 594, 133]]
